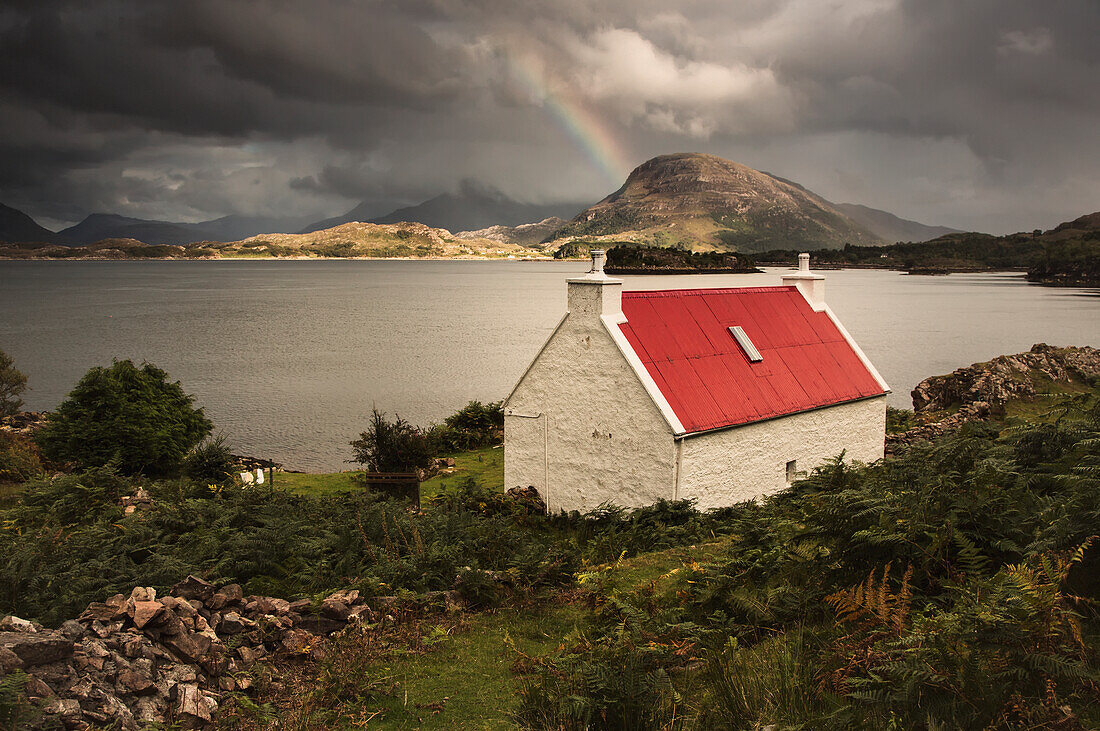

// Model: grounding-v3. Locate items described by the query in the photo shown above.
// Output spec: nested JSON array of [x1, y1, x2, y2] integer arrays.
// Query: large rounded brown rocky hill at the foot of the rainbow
[[552, 153, 883, 252]]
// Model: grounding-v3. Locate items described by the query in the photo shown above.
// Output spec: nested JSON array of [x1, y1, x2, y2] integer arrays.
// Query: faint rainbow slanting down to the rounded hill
[[509, 54, 634, 188]]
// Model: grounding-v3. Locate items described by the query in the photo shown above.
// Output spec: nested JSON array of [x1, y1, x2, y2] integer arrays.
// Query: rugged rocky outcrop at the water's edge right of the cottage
[[887, 343, 1100, 454]]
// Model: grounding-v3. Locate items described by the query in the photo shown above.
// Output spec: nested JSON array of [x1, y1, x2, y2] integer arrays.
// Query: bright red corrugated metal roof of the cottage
[[619, 287, 884, 433]]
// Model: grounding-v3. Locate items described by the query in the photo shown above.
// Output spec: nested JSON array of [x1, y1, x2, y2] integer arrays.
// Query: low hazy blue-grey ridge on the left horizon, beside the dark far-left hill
[[59, 213, 312, 244]]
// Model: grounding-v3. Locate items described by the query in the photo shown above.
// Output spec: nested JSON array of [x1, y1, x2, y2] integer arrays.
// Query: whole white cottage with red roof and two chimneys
[[504, 251, 889, 512]]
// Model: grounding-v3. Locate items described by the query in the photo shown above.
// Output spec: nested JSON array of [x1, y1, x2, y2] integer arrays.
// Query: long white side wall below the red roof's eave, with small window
[[677, 396, 887, 510]]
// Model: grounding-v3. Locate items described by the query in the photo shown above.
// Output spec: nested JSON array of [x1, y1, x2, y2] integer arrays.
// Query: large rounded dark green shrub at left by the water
[[35, 361, 212, 476]]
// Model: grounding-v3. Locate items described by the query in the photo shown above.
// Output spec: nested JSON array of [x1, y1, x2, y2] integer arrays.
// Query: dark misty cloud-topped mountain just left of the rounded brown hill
[[303, 180, 585, 233]]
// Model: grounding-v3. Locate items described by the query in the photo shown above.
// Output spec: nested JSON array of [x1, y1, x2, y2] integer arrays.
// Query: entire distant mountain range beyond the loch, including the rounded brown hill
[[0, 153, 955, 252]]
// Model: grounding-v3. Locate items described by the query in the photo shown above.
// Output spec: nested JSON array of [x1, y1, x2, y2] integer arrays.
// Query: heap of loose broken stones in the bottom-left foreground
[[0, 576, 460, 729]]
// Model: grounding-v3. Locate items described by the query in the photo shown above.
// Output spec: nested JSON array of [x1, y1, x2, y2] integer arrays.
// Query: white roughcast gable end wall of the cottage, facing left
[[504, 283, 677, 512]]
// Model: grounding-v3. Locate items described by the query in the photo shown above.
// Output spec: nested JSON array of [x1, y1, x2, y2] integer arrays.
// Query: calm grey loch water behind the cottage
[[0, 261, 1100, 470]]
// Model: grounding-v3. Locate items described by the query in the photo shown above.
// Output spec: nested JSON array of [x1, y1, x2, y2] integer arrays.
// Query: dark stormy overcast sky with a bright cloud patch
[[0, 0, 1100, 233]]
